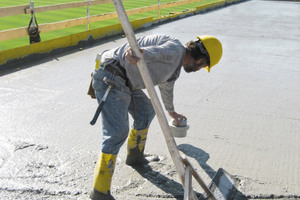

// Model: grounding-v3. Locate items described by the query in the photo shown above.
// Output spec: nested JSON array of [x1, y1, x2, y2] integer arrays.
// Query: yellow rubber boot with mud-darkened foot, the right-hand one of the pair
[[126, 129, 148, 166]]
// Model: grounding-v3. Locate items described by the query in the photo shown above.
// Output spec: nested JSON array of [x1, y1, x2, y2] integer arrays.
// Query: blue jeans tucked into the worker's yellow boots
[[93, 69, 155, 154]]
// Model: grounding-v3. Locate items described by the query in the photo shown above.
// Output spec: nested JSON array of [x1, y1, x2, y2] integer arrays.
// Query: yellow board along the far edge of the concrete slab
[[0, 0, 247, 69]]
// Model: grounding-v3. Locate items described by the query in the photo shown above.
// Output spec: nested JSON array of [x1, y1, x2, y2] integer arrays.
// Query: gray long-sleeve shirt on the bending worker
[[98, 35, 185, 112]]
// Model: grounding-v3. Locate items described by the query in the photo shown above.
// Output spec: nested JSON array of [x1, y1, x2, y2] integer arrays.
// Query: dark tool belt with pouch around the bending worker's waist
[[87, 60, 131, 99]]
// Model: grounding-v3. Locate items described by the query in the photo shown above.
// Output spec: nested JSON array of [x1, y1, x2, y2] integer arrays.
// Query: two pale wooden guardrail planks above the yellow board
[[0, 0, 203, 41]]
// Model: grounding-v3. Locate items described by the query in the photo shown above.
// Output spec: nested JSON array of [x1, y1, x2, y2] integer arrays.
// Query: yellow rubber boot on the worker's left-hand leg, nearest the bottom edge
[[90, 153, 117, 200]]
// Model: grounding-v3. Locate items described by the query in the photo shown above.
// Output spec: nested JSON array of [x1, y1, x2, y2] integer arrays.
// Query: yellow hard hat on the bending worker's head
[[197, 35, 223, 72]]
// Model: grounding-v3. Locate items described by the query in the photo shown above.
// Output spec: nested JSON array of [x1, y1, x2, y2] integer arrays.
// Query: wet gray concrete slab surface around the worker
[[0, 0, 300, 199]]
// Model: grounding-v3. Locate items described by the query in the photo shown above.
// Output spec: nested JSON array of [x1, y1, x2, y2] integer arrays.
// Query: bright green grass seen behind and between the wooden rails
[[0, 0, 219, 51]]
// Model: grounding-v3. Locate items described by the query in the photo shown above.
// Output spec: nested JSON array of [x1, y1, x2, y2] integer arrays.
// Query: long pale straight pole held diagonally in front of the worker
[[112, 0, 214, 200]]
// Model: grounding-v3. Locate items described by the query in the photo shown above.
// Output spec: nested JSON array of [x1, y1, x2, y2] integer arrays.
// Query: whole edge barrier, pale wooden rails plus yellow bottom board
[[0, 0, 245, 68]]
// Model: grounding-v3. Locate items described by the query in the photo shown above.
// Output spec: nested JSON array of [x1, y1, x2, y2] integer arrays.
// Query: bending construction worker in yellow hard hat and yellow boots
[[90, 35, 222, 200]]
